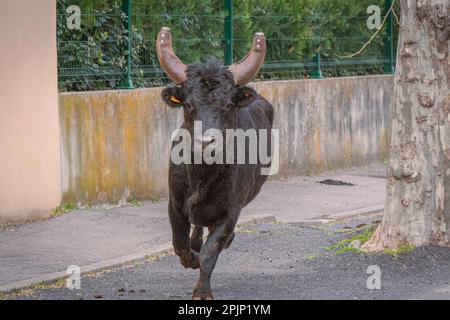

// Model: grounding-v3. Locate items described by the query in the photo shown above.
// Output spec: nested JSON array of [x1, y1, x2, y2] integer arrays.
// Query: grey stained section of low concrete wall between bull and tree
[[255, 76, 394, 177]]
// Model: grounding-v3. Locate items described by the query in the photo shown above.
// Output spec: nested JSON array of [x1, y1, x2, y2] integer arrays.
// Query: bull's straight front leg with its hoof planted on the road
[[192, 217, 237, 300]]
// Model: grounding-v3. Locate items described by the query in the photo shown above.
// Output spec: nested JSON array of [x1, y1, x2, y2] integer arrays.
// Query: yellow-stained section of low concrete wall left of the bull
[[60, 90, 176, 204]]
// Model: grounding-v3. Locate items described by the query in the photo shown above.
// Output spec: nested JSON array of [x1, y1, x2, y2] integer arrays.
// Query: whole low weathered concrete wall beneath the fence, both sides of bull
[[59, 76, 393, 203]]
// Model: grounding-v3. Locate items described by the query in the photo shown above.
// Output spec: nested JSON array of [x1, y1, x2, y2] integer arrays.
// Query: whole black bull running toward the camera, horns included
[[156, 27, 273, 299]]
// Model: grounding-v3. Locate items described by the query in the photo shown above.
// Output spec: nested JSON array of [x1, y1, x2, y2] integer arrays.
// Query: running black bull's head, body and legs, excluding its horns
[[162, 59, 273, 299]]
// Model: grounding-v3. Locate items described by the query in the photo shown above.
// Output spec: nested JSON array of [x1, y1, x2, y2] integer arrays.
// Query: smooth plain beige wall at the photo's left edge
[[0, 0, 61, 224]]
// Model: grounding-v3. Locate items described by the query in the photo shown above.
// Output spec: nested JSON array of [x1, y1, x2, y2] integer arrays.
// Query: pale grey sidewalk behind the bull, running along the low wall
[[0, 166, 385, 291]]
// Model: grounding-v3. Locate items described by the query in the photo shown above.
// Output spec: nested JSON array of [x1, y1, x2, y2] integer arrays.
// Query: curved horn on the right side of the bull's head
[[230, 32, 266, 86]]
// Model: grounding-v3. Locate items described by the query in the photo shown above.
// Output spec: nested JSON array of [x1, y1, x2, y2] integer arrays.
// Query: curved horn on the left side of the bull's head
[[156, 27, 187, 85]]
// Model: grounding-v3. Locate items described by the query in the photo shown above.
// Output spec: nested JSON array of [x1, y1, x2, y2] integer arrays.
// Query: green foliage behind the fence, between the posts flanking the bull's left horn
[[128, 0, 225, 86]]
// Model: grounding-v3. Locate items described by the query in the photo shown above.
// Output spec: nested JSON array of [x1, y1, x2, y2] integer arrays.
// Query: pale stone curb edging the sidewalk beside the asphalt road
[[0, 214, 276, 293]]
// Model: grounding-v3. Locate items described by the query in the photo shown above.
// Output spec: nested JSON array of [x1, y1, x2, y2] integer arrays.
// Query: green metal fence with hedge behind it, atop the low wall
[[57, 0, 398, 91]]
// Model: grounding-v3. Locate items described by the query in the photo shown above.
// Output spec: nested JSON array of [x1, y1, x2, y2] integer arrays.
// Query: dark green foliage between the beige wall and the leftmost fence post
[[57, 0, 145, 91]]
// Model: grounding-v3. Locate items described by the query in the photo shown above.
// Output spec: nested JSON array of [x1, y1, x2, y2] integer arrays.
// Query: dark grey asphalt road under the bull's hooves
[[3, 217, 450, 299]]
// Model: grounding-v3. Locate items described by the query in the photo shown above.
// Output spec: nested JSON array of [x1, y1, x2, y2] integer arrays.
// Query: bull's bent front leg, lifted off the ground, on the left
[[169, 200, 199, 269]]
